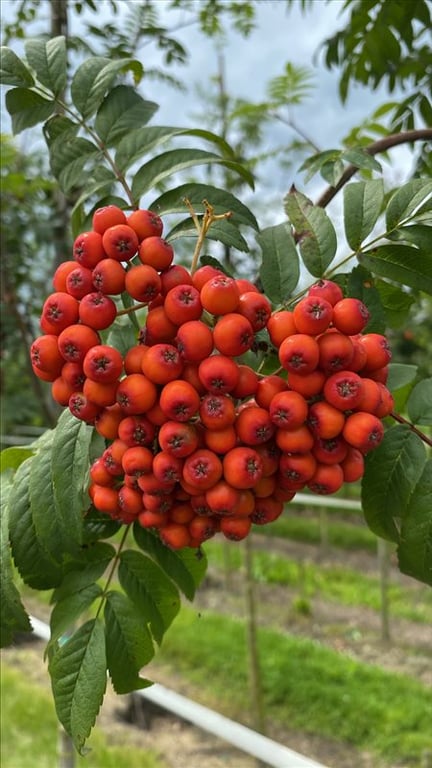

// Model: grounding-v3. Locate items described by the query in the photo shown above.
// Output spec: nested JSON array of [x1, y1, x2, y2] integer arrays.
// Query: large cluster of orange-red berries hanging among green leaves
[[31, 205, 393, 548]]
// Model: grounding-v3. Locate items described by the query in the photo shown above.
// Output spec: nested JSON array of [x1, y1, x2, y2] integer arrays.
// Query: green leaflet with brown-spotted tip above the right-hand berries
[[284, 189, 337, 277]]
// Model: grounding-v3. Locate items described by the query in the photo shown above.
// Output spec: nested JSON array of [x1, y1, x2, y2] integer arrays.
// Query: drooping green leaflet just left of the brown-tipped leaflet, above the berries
[[257, 222, 300, 304]]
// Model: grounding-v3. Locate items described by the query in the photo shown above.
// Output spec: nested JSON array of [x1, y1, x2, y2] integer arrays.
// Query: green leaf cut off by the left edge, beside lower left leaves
[[0, 477, 31, 648]]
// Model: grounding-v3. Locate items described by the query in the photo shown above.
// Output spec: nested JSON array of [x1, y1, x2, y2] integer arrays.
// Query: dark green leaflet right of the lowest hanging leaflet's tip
[[105, 592, 154, 693]]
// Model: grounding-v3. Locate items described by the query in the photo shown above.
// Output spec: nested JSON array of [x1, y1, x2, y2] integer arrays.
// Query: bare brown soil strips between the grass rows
[[2, 536, 432, 768]]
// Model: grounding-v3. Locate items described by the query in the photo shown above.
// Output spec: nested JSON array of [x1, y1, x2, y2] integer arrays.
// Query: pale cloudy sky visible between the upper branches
[[0, 0, 409, 225]]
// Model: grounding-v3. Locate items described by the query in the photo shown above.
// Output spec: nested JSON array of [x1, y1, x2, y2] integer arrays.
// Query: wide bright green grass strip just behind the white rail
[[160, 608, 432, 765]]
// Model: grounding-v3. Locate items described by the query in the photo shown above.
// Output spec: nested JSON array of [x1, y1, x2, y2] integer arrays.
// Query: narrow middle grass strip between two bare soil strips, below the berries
[[205, 541, 432, 623]]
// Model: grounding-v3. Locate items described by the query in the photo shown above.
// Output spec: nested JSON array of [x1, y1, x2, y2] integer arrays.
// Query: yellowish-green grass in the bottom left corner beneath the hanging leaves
[[1, 662, 165, 768]]
